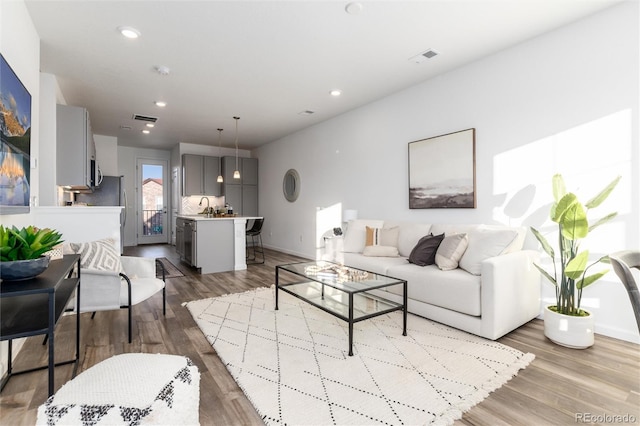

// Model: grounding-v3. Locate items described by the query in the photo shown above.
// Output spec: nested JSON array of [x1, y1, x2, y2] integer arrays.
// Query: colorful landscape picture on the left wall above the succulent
[[0, 54, 31, 214]]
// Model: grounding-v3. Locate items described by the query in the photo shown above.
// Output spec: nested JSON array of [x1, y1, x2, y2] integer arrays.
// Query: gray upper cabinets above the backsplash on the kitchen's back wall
[[182, 154, 222, 196]]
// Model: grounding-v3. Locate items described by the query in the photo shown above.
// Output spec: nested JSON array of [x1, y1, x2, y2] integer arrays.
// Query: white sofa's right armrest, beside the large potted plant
[[481, 250, 540, 340]]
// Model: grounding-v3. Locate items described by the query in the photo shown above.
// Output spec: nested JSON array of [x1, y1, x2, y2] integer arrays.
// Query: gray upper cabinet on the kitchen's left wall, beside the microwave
[[56, 105, 98, 190]]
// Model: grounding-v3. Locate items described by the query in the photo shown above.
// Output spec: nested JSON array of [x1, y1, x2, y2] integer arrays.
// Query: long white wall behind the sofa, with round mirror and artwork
[[254, 2, 640, 341]]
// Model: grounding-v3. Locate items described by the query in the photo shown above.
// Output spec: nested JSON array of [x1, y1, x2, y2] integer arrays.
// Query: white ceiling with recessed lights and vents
[[26, 0, 618, 149]]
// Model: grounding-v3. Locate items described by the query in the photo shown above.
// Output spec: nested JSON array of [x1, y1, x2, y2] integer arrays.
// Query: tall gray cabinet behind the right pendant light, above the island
[[222, 157, 258, 216]]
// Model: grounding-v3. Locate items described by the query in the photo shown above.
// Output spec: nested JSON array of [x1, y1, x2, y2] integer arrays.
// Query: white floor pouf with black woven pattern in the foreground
[[37, 353, 200, 425]]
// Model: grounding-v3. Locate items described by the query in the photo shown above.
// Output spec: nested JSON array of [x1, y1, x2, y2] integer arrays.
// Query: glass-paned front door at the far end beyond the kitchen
[[136, 158, 169, 244]]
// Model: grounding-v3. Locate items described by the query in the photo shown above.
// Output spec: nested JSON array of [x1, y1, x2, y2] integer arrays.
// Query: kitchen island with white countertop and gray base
[[176, 214, 262, 274]]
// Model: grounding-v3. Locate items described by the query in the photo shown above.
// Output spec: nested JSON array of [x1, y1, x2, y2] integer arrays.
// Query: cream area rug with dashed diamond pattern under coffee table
[[187, 287, 534, 425]]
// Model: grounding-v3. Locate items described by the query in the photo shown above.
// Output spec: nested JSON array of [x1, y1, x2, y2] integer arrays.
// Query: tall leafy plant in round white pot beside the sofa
[[531, 174, 620, 349]]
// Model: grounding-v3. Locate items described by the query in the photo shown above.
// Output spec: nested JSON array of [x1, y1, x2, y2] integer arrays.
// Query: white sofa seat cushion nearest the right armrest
[[386, 264, 482, 316]]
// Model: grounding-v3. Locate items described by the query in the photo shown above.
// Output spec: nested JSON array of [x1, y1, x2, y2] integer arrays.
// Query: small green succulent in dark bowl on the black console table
[[0, 225, 62, 281]]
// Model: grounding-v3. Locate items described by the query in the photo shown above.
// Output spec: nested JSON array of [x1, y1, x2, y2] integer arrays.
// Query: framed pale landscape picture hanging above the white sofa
[[409, 129, 476, 209]]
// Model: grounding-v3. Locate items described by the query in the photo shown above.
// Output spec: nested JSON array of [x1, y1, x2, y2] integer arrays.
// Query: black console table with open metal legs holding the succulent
[[0, 254, 80, 396]]
